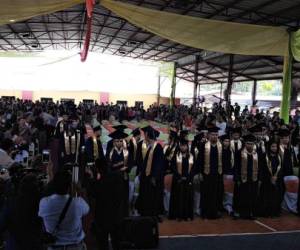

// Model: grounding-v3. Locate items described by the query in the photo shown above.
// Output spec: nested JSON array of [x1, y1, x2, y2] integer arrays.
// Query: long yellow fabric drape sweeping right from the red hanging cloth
[[100, 0, 289, 56]]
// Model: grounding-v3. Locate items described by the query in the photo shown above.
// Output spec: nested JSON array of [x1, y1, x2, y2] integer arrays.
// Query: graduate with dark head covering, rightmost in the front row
[[259, 141, 283, 217]]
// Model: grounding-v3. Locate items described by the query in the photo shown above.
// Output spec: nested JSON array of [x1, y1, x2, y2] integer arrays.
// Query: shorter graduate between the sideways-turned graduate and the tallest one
[[169, 139, 194, 220]]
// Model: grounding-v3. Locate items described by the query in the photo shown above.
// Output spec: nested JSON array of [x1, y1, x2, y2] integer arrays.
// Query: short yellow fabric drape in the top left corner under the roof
[[0, 0, 85, 25]]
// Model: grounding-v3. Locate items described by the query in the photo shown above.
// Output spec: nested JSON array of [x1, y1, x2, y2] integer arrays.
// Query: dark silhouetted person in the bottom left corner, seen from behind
[[0, 174, 43, 250]]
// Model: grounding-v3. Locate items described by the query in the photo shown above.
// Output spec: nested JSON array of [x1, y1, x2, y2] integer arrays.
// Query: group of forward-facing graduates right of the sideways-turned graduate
[[165, 125, 297, 219]]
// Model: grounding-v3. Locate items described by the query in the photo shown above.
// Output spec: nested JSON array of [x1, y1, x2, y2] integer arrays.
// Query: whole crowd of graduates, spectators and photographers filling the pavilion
[[0, 99, 300, 250]]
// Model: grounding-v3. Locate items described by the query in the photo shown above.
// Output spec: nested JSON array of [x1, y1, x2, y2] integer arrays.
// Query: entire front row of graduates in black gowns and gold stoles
[[52, 117, 293, 219]]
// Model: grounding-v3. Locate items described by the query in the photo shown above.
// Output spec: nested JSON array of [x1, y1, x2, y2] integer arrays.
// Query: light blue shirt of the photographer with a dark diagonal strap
[[39, 194, 90, 245]]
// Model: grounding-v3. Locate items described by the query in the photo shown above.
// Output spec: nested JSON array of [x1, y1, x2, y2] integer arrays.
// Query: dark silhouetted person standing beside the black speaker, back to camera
[[89, 158, 126, 250]]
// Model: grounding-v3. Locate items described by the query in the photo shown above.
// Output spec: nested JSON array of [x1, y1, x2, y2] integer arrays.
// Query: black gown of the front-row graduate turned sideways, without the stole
[[136, 143, 164, 216]]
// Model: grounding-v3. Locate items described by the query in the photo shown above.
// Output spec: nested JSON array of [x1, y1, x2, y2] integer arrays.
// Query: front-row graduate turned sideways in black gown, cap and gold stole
[[136, 126, 164, 220]]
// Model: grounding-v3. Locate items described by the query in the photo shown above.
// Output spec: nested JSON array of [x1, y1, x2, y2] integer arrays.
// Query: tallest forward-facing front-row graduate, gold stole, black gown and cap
[[197, 127, 224, 219]]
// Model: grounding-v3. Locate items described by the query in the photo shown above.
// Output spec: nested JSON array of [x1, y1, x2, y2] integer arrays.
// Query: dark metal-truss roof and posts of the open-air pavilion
[[0, 0, 300, 121]]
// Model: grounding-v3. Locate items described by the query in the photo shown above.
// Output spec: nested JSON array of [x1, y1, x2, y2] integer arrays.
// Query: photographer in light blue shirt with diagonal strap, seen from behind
[[38, 170, 89, 250]]
